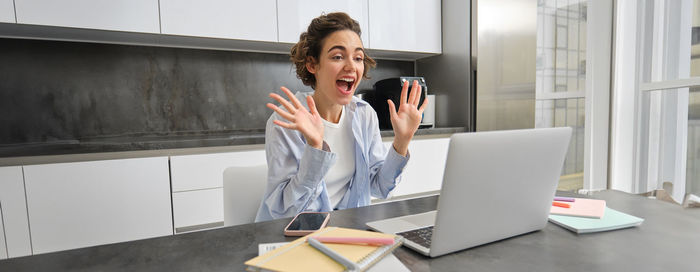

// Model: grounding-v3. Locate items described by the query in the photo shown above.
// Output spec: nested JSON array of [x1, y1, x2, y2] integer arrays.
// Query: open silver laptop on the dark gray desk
[[367, 127, 571, 257]]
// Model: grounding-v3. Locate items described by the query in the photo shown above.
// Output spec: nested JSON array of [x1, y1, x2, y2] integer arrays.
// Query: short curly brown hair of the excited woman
[[289, 12, 377, 88]]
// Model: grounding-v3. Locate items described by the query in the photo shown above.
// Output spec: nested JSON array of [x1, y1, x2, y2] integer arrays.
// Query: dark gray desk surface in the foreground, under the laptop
[[0, 191, 700, 271]]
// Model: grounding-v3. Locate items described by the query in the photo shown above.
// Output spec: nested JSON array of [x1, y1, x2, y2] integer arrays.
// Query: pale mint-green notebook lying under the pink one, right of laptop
[[549, 207, 644, 234]]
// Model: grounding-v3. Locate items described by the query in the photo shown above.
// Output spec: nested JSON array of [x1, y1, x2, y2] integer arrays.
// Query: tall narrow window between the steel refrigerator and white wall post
[[535, 0, 588, 191]]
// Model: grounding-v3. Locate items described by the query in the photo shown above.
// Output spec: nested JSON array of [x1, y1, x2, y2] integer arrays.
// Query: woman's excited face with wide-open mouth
[[306, 30, 365, 105]]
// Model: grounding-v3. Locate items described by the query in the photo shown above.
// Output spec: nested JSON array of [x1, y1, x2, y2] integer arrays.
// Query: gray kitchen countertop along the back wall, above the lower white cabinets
[[0, 127, 466, 166]]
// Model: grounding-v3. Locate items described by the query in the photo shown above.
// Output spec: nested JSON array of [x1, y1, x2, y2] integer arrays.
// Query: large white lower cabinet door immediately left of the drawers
[[24, 157, 173, 254]]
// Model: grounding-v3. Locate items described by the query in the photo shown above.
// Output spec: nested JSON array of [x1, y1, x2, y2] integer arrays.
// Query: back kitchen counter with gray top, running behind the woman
[[0, 127, 466, 166]]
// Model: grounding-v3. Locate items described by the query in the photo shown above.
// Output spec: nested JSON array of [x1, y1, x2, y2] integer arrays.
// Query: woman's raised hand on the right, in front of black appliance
[[387, 80, 428, 156]]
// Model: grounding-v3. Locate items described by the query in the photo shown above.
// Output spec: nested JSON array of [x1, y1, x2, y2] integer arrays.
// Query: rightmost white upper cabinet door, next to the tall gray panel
[[369, 0, 440, 53]]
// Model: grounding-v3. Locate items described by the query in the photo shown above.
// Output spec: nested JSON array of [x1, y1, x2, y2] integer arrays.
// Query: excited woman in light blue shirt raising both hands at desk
[[256, 13, 428, 221]]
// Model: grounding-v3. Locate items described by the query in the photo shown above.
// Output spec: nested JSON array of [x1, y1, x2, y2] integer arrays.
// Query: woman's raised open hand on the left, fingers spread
[[267, 87, 323, 149]]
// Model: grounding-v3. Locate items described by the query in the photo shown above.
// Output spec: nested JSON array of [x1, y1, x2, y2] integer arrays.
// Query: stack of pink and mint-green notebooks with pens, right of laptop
[[549, 198, 644, 234]]
